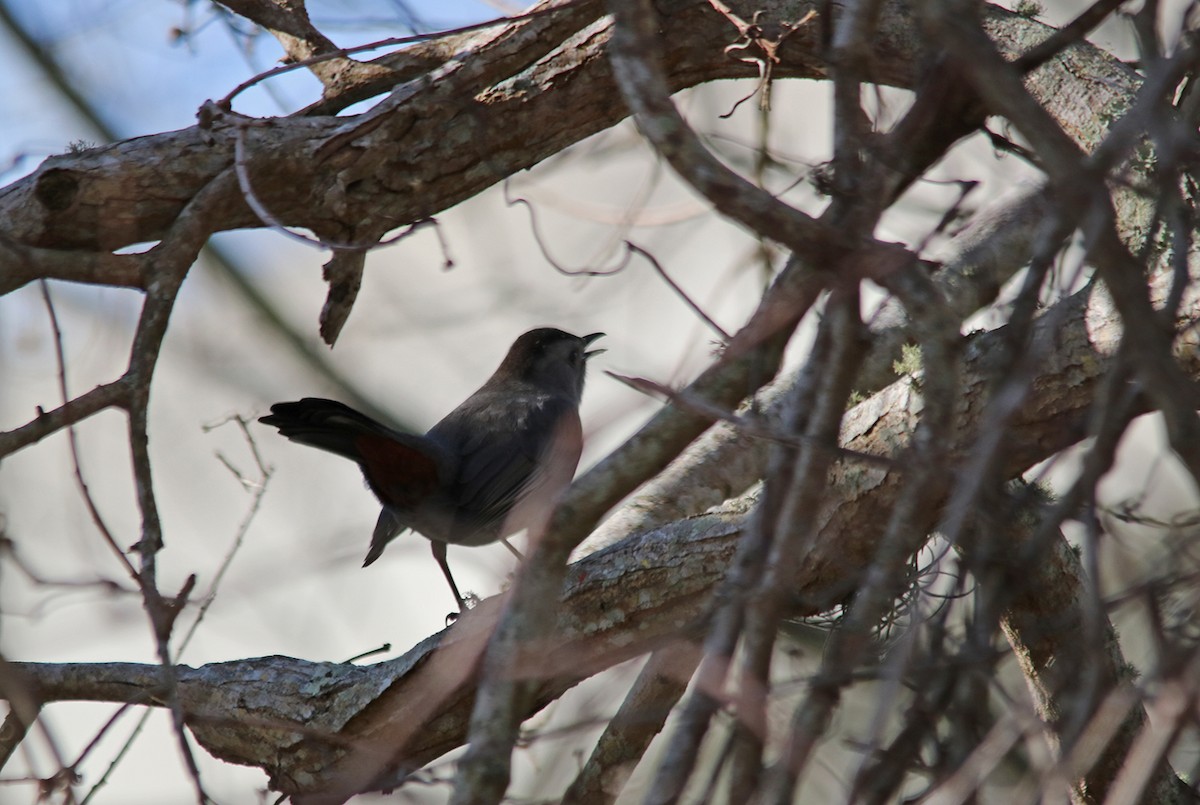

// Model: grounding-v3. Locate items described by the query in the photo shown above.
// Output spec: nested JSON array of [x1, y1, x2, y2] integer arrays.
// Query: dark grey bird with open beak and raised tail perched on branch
[[258, 328, 605, 612]]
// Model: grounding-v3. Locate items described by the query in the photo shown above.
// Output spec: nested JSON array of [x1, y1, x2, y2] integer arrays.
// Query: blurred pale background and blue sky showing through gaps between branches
[[0, 0, 1200, 805]]
